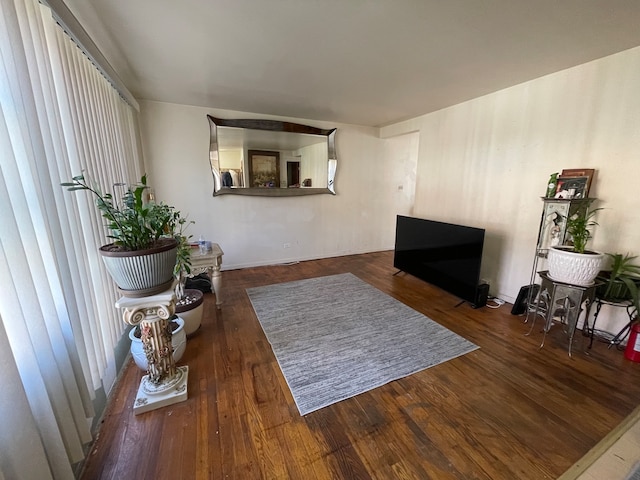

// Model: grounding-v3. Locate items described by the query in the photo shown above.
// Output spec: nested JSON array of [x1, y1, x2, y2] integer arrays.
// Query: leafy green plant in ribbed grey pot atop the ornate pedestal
[[61, 171, 192, 297]]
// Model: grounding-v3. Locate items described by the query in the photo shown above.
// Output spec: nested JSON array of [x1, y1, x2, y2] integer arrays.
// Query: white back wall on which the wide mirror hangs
[[140, 101, 417, 269]]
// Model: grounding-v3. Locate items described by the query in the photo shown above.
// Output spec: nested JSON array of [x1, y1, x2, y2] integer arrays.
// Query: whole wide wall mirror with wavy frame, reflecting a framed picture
[[207, 115, 338, 197]]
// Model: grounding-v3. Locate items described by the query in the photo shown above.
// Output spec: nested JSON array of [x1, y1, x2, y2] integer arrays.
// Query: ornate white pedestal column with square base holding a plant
[[116, 290, 189, 415]]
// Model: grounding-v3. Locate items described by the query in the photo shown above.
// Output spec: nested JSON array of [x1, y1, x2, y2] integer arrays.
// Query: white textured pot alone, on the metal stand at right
[[547, 247, 604, 286]]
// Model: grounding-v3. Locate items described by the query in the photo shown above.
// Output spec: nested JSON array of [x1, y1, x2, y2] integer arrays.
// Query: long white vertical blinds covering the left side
[[0, 0, 142, 479]]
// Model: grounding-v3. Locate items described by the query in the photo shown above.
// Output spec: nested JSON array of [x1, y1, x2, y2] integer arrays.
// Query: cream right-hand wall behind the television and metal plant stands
[[381, 47, 640, 301]]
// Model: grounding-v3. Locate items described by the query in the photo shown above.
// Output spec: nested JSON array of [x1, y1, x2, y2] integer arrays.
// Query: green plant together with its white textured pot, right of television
[[547, 201, 604, 286]]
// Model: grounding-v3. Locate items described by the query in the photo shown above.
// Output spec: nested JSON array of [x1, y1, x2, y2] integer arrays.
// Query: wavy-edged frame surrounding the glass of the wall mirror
[[207, 115, 338, 197]]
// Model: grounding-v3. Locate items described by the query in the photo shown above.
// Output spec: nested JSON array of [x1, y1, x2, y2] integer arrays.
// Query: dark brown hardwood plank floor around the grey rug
[[82, 252, 640, 480]]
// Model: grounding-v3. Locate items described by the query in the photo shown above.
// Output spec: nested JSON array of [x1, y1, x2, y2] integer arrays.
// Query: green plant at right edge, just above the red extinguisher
[[598, 253, 640, 312]]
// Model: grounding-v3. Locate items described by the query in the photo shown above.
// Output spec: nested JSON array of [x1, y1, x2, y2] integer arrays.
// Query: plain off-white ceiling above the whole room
[[64, 0, 640, 126]]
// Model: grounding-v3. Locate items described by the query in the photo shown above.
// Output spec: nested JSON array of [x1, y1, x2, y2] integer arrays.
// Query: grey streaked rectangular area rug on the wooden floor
[[247, 273, 478, 415]]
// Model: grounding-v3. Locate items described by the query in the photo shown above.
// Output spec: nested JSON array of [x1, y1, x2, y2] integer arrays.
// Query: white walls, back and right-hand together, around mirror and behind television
[[141, 47, 640, 334]]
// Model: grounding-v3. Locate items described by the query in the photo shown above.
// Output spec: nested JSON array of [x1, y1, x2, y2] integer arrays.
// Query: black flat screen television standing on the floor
[[393, 215, 484, 305]]
